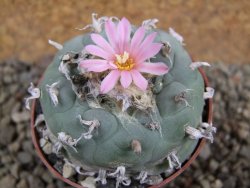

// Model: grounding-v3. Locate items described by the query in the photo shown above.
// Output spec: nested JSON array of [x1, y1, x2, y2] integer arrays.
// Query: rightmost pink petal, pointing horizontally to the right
[[136, 62, 169, 75]]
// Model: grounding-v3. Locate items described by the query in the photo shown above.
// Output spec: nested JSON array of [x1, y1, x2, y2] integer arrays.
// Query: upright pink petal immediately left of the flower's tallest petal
[[105, 19, 117, 53]]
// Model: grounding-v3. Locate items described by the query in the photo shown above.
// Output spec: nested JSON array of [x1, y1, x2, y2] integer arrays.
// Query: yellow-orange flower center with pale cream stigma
[[115, 51, 135, 70]]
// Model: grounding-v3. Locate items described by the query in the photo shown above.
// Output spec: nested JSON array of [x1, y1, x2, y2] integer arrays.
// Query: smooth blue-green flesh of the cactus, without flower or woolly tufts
[[39, 27, 204, 174]]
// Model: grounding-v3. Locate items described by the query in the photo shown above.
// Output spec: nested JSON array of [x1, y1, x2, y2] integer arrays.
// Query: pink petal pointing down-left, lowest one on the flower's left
[[101, 70, 120, 93]]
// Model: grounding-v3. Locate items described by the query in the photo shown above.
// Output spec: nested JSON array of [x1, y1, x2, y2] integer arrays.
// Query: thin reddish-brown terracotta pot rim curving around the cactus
[[30, 68, 213, 188]]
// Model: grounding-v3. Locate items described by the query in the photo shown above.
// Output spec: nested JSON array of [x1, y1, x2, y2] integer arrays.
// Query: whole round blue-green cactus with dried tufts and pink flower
[[27, 14, 216, 187]]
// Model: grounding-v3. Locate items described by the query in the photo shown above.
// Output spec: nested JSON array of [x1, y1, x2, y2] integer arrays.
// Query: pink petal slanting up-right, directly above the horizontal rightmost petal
[[135, 43, 162, 63]]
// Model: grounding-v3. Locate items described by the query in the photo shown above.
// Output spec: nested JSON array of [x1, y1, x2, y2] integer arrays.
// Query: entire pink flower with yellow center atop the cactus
[[80, 18, 168, 93]]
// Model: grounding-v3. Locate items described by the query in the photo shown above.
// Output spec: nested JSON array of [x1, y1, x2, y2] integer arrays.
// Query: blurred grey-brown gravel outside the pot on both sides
[[0, 59, 250, 188]]
